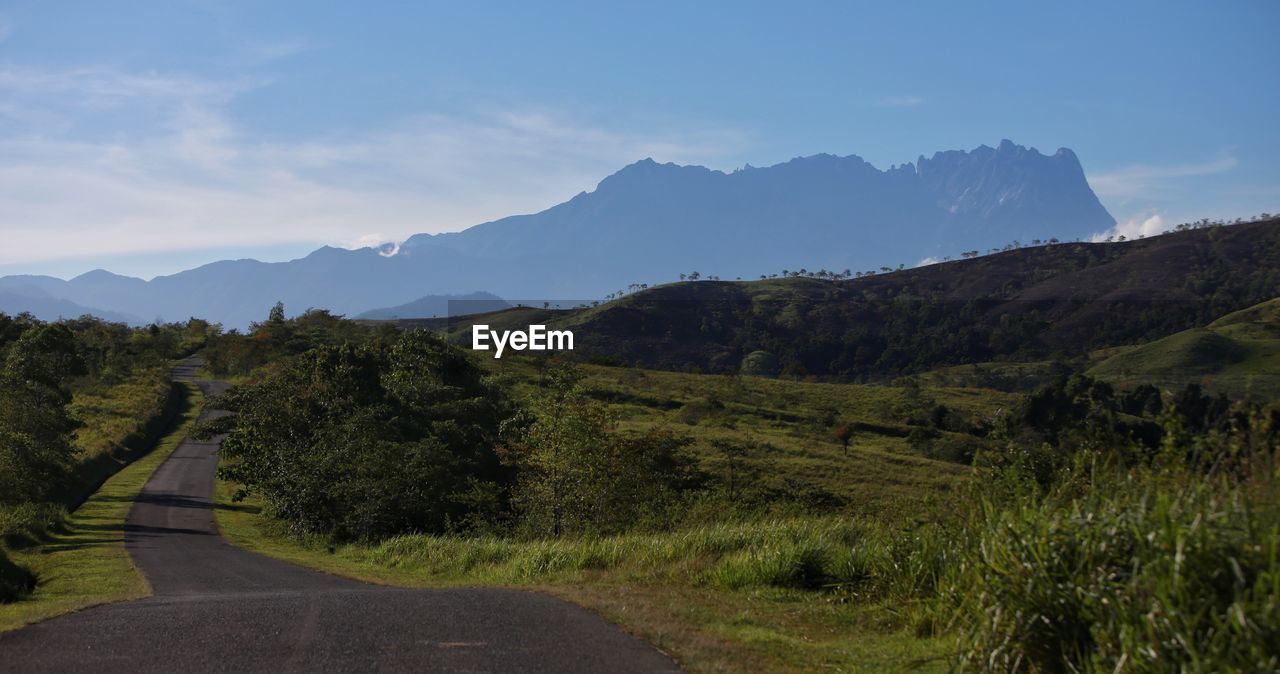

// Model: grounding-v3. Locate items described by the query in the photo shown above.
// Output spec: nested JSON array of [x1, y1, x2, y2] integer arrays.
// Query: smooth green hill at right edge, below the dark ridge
[[1089, 299, 1280, 398]]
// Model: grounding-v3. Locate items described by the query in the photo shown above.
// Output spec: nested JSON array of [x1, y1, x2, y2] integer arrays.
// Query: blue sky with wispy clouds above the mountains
[[0, 0, 1280, 278]]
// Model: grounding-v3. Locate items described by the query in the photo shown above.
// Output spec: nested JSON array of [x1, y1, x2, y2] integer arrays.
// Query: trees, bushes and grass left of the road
[[0, 315, 215, 608]]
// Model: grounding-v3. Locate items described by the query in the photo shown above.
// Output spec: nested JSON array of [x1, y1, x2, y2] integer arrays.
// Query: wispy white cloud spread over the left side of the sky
[[0, 68, 742, 265]]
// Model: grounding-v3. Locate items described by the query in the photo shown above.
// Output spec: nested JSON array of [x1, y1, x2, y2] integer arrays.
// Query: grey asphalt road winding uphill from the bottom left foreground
[[0, 362, 678, 673]]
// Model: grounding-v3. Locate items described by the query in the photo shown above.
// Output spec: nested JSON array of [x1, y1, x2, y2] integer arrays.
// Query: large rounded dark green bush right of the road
[[221, 333, 512, 538]]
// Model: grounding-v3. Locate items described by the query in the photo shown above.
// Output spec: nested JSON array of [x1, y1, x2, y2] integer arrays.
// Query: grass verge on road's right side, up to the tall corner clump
[[215, 482, 954, 671]]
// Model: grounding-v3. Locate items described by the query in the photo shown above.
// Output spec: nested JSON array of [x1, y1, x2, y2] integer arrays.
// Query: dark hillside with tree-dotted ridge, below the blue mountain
[[399, 220, 1280, 380]]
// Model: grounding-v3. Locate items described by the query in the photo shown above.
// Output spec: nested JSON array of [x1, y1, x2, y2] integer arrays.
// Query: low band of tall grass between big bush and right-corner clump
[[330, 518, 931, 591]]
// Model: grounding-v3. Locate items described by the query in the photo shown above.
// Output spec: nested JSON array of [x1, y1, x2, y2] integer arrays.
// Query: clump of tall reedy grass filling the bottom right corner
[[941, 473, 1280, 671]]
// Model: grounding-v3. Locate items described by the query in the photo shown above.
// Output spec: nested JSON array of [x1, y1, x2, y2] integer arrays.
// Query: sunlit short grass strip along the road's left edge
[[0, 385, 200, 632]]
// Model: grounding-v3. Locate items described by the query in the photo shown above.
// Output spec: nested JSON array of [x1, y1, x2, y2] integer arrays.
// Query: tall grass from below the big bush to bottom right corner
[[293, 455, 1280, 671]]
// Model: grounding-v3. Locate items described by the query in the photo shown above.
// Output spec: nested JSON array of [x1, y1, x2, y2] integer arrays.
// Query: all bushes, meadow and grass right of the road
[[207, 306, 1280, 671]]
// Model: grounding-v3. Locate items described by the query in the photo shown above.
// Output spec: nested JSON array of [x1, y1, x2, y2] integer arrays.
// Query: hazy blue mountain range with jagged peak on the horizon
[[0, 141, 1115, 327]]
